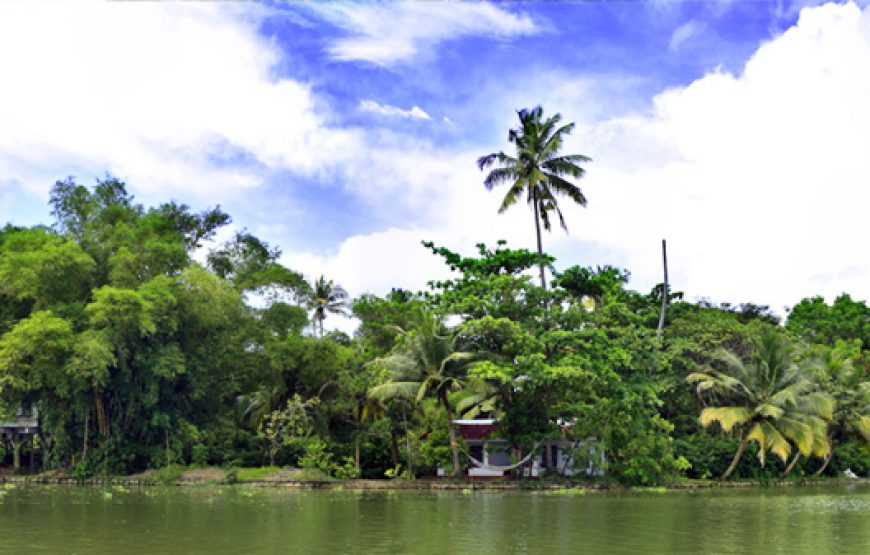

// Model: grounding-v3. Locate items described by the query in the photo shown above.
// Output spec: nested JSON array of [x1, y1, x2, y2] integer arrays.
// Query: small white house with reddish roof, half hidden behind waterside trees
[[453, 418, 605, 478]]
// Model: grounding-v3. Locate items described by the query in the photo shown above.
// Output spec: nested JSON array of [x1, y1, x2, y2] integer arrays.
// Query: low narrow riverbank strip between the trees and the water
[[0, 468, 870, 492]]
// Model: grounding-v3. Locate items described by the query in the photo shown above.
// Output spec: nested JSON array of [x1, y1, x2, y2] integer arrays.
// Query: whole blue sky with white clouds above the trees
[[0, 0, 870, 328]]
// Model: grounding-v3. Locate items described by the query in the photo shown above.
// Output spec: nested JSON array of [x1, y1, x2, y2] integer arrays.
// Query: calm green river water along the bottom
[[0, 486, 870, 555]]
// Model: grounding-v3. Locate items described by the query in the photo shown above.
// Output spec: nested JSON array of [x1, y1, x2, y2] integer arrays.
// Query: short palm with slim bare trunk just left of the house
[[369, 313, 475, 477]]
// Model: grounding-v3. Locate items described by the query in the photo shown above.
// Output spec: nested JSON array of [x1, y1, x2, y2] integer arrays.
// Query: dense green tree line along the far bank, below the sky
[[0, 179, 870, 484]]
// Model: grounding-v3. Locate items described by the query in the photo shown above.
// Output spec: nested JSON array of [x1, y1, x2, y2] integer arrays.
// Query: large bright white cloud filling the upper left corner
[[0, 3, 357, 199]]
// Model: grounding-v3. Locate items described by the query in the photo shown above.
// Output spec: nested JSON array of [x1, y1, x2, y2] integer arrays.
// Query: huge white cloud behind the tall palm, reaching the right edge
[[286, 1, 870, 322]]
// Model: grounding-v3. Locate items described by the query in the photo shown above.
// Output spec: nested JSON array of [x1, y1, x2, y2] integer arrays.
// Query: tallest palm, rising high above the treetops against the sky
[[477, 106, 591, 288]]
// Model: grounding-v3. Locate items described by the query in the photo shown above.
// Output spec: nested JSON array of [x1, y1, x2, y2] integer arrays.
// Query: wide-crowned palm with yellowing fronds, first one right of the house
[[686, 332, 833, 480]]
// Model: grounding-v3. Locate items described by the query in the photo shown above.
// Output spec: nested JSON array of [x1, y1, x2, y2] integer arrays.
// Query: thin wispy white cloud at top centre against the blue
[[308, 2, 541, 66]]
